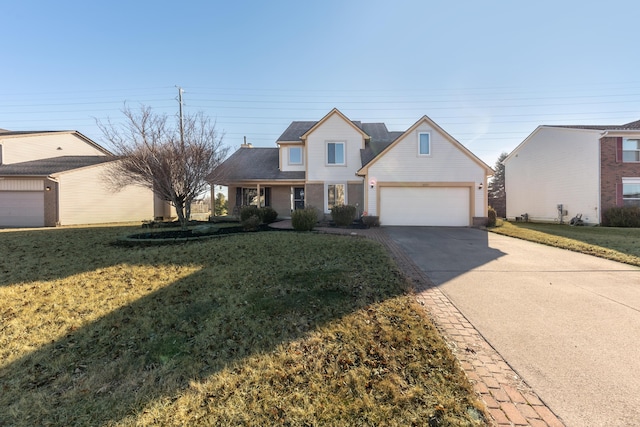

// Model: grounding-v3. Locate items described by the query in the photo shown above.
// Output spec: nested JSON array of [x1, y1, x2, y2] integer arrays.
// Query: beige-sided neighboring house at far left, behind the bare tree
[[0, 131, 160, 227]]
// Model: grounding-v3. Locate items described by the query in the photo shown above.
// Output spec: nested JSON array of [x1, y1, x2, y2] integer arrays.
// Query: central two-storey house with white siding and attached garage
[[208, 109, 493, 226]]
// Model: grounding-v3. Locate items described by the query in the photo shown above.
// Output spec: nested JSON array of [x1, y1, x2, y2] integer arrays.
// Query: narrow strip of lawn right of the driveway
[[489, 222, 640, 266]]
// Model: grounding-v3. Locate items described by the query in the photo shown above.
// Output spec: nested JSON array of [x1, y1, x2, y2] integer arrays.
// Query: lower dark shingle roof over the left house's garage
[[0, 156, 115, 176]]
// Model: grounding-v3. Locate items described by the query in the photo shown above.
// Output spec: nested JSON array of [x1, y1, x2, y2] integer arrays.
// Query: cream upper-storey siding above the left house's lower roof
[[0, 133, 105, 165]]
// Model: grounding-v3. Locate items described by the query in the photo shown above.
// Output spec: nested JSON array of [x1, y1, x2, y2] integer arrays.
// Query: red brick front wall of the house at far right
[[600, 137, 640, 220]]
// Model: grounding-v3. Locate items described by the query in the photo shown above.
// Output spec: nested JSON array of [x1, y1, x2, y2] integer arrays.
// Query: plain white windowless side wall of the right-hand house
[[505, 127, 600, 223]]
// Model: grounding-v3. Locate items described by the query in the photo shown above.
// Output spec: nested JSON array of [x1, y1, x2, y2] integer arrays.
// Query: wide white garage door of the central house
[[380, 187, 469, 227]]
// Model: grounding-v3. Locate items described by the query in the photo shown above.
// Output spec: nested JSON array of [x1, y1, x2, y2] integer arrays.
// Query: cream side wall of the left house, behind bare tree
[[56, 165, 154, 225]]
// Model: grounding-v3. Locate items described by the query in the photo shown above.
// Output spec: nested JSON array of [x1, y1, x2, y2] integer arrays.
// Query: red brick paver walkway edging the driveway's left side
[[272, 221, 564, 427]]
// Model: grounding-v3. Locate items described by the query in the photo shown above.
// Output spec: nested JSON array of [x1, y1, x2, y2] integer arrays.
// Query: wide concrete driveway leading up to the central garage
[[384, 227, 640, 427]]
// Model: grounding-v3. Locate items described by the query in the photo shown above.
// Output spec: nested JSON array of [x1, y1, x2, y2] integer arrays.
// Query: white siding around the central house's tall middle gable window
[[306, 114, 364, 184]]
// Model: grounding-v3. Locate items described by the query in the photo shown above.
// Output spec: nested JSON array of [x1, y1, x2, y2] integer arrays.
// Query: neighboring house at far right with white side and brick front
[[504, 120, 640, 224]]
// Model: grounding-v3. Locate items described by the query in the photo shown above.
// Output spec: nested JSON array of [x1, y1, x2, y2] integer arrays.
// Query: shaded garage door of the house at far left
[[0, 191, 44, 227]]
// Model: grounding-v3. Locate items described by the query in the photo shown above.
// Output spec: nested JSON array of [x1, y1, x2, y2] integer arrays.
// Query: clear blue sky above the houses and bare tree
[[0, 0, 640, 166]]
